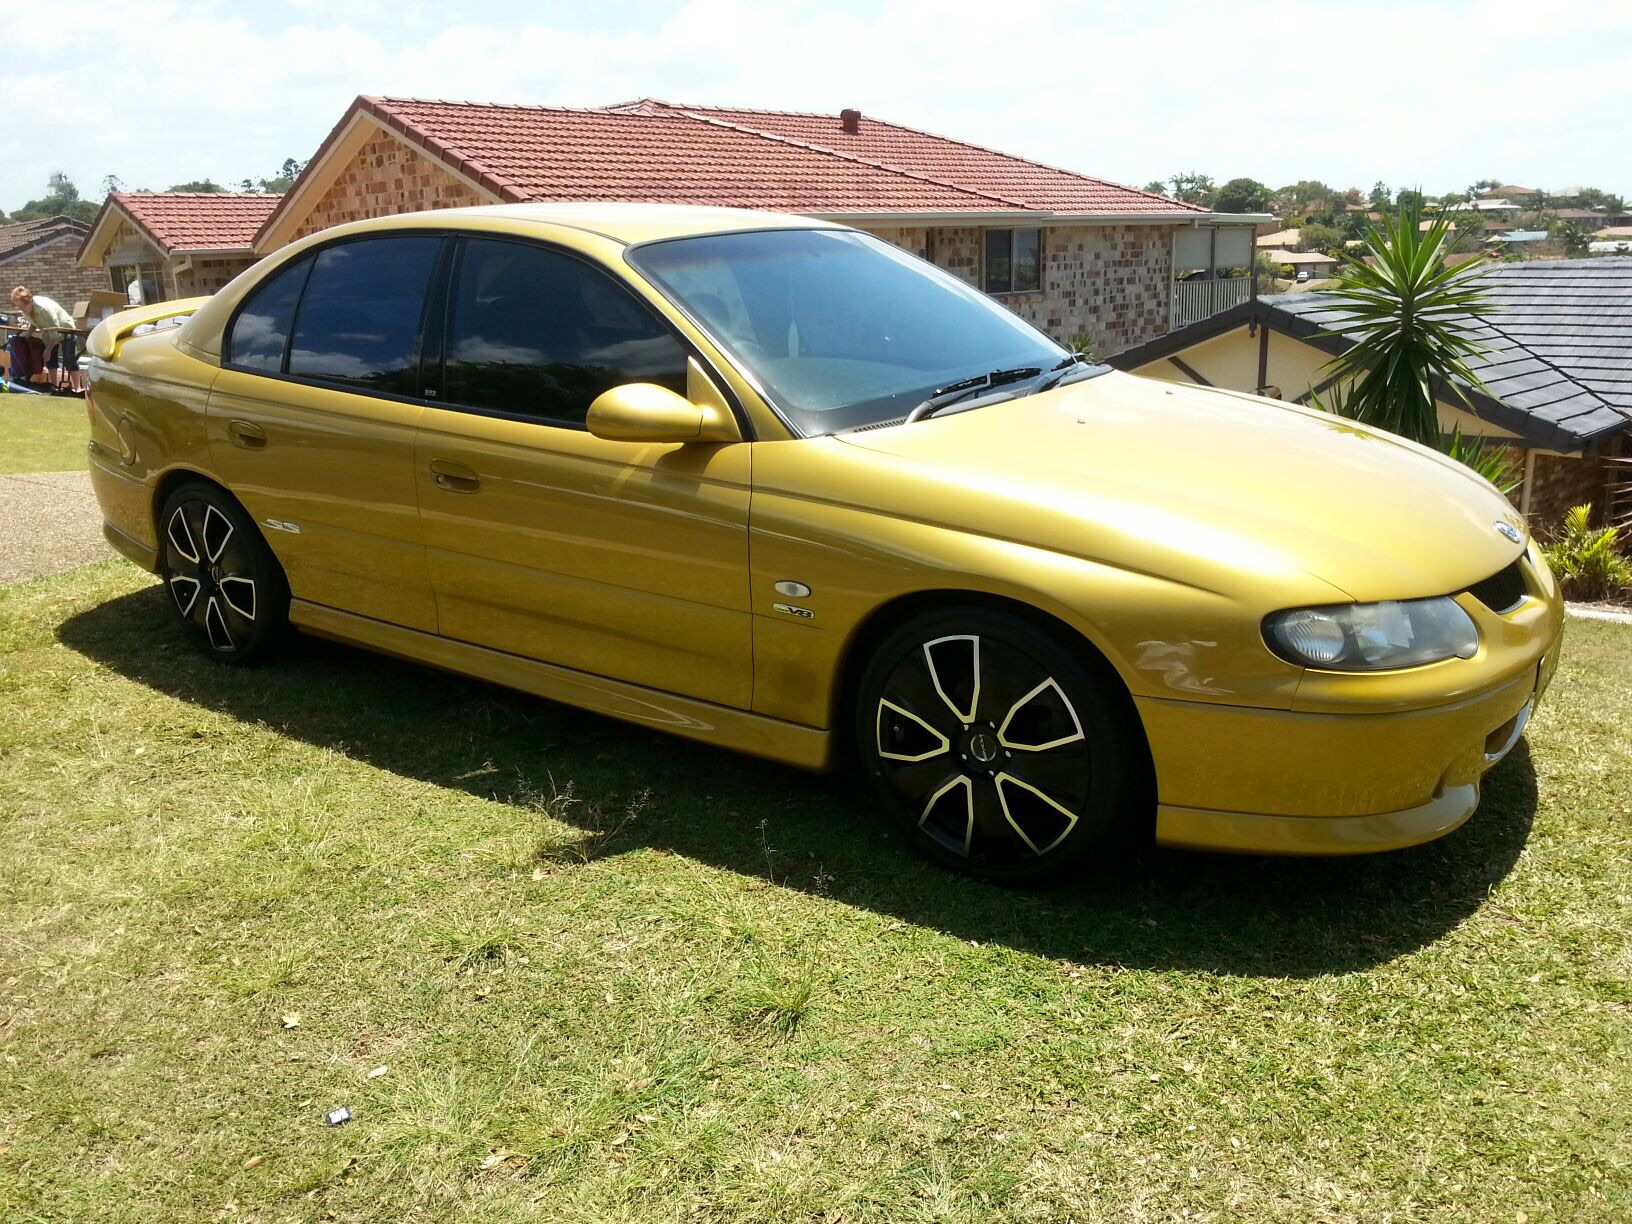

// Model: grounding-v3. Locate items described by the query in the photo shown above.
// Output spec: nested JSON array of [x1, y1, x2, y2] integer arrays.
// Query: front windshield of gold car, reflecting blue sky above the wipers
[[628, 230, 1066, 434]]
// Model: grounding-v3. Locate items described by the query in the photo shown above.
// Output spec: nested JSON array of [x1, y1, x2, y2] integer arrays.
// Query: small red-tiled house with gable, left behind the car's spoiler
[[78, 191, 281, 302]]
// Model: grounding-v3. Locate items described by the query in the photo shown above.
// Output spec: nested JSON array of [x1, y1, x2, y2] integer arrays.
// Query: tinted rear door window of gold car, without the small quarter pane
[[289, 235, 442, 395]]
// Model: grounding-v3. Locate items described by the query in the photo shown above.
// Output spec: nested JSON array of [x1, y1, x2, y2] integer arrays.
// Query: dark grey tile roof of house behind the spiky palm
[[1260, 256, 1632, 450]]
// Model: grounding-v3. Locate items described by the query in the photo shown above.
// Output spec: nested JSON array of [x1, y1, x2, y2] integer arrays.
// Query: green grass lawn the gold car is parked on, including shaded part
[[0, 564, 1632, 1224]]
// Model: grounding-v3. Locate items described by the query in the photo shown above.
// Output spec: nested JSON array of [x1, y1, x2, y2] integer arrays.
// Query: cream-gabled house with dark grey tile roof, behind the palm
[[1111, 256, 1632, 529]]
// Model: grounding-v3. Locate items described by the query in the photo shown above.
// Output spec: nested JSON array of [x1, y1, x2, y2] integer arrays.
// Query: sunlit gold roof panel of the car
[[373, 201, 844, 245]]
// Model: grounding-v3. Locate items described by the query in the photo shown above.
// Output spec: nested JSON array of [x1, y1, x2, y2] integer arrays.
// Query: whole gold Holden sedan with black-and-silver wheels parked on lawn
[[90, 204, 1562, 881]]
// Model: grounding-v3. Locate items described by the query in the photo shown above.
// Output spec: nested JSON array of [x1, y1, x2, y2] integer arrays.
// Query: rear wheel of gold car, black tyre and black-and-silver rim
[[158, 480, 289, 664]]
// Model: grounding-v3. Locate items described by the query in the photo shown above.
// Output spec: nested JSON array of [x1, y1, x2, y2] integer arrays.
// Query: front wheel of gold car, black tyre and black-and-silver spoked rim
[[855, 607, 1144, 885]]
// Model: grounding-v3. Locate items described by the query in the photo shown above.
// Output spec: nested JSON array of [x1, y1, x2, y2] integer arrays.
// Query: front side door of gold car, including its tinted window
[[416, 237, 752, 708]]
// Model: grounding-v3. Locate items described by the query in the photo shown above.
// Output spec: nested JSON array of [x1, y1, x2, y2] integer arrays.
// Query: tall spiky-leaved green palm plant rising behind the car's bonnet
[[1327, 207, 1485, 447]]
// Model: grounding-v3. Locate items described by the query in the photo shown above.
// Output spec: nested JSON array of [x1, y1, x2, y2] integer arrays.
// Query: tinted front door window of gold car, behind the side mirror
[[442, 238, 685, 424]]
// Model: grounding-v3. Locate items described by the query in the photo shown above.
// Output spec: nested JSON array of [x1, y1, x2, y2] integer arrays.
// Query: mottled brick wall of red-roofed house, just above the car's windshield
[[868, 225, 1173, 357]]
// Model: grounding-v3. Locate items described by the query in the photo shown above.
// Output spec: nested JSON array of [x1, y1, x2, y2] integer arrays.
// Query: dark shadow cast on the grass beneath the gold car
[[59, 586, 1536, 978]]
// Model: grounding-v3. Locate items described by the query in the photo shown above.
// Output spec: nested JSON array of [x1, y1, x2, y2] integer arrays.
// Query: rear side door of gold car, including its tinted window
[[207, 232, 444, 632]]
